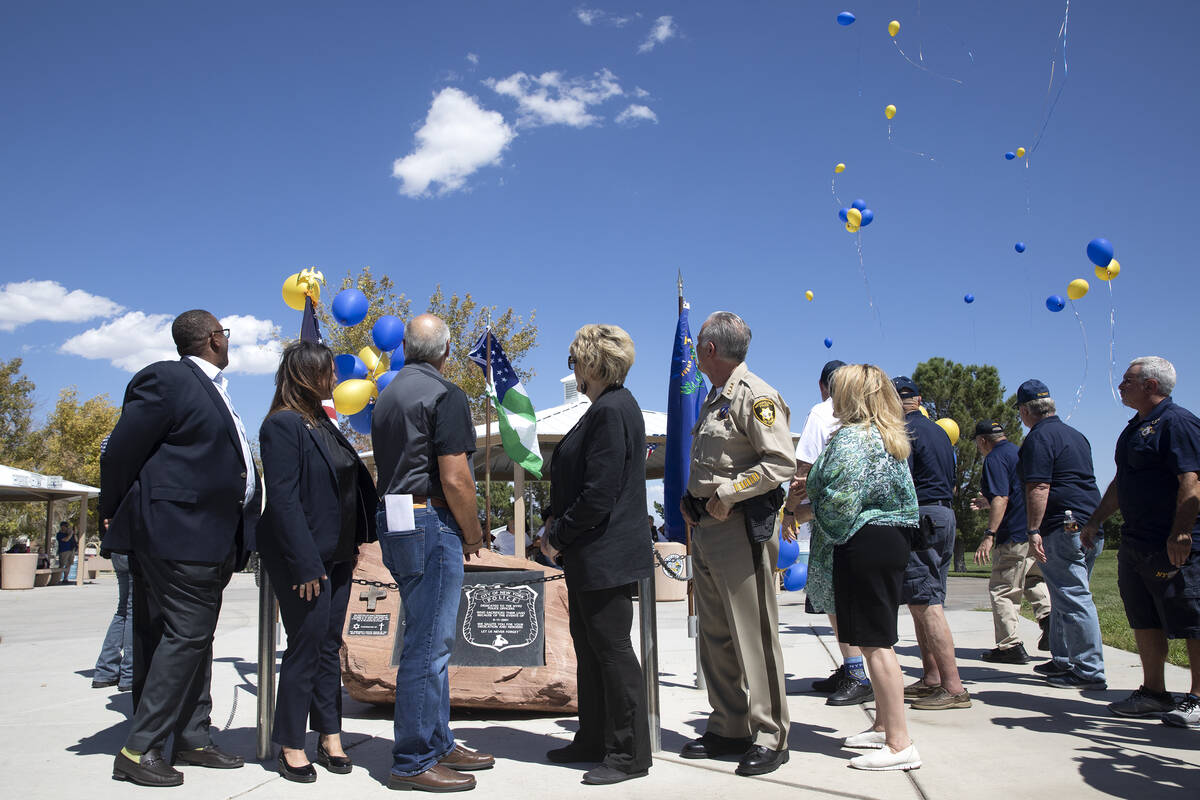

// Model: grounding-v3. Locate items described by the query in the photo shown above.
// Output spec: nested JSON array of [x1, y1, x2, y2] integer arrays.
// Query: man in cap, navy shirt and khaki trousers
[[971, 420, 1050, 664]]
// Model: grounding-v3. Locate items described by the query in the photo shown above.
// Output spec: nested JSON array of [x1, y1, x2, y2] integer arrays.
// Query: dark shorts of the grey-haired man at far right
[[1117, 542, 1200, 639]]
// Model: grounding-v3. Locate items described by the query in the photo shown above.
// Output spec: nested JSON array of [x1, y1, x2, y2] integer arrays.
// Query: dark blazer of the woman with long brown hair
[[258, 411, 378, 589]]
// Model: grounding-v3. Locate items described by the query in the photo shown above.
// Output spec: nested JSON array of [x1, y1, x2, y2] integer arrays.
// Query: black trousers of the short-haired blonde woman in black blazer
[[566, 579, 650, 772]]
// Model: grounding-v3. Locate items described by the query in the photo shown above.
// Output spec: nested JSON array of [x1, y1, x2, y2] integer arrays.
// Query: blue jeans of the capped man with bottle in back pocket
[[1042, 528, 1104, 680]]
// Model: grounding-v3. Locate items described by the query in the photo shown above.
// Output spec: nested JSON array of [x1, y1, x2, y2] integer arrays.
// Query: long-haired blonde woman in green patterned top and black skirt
[[808, 363, 920, 770]]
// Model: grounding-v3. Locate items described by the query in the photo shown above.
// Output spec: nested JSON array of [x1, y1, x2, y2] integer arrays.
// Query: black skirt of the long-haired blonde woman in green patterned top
[[833, 525, 913, 648]]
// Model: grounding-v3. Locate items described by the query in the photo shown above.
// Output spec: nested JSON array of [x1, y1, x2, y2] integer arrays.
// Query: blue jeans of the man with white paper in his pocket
[[378, 506, 463, 777]]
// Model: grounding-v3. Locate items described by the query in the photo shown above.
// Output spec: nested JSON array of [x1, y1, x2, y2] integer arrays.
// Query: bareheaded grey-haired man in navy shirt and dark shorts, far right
[[1081, 356, 1200, 728]]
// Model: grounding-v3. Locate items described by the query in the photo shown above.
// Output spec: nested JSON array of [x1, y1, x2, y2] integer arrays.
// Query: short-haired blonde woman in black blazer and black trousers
[[542, 325, 656, 783]]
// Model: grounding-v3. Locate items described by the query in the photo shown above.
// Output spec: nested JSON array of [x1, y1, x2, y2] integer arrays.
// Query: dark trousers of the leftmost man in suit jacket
[[125, 554, 234, 752]]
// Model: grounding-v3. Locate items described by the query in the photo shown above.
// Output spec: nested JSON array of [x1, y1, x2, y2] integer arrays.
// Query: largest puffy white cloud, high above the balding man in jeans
[[391, 89, 516, 197]]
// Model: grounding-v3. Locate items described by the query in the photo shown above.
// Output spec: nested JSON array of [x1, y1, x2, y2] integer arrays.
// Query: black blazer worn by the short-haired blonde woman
[[547, 386, 653, 591]]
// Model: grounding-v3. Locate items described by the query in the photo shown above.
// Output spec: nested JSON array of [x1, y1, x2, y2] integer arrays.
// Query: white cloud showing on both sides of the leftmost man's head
[[60, 311, 281, 374]]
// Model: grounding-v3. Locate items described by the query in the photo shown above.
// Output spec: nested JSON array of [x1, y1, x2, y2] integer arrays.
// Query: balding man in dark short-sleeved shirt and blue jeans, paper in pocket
[[371, 314, 493, 792]]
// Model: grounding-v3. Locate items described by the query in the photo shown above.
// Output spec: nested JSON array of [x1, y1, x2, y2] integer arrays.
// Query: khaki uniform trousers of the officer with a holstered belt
[[691, 511, 788, 750]]
